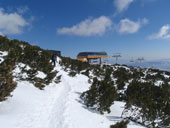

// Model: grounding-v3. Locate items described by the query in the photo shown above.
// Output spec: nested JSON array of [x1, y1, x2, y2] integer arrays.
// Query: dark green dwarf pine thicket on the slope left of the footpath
[[0, 36, 61, 101]]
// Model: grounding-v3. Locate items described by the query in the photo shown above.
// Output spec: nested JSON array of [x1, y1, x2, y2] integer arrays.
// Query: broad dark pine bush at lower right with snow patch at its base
[[123, 80, 170, 128]]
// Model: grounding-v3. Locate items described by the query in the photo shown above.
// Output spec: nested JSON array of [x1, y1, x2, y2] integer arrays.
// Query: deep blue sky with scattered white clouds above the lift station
[[0, 0, 170, 60]]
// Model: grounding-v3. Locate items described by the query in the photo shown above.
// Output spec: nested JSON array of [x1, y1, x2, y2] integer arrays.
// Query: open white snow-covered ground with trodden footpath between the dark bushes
[[0, 61, 146, 128]]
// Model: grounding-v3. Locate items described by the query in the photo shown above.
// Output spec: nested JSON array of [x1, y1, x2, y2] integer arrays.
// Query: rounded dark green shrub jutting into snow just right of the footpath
[[81, 77, 117, 114]]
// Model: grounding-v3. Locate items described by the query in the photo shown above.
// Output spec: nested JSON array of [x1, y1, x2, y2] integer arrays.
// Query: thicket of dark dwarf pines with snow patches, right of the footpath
[[81, 65, 170, 128]]
